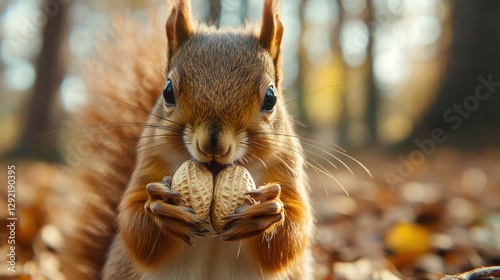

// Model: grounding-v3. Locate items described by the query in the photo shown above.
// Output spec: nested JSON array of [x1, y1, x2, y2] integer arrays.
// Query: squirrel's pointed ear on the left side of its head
[[166, 0, 193, 59]]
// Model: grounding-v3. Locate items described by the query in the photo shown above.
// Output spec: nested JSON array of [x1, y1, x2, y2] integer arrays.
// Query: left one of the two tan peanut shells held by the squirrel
[[171, 160, 214, 220]]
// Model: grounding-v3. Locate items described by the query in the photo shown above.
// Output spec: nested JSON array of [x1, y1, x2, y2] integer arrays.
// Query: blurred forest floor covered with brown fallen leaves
[[0, 148, 500, 280]]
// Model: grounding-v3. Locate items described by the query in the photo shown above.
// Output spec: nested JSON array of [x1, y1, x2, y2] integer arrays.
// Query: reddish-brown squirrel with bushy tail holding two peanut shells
[[61, 0, 314, 280]]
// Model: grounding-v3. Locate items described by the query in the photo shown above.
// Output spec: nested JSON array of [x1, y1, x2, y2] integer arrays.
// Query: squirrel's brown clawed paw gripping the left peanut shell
[[144, 178, 209, 245]]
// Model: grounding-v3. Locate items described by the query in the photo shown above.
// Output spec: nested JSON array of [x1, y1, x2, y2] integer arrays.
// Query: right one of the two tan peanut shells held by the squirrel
[[210, 165, 256, 232]]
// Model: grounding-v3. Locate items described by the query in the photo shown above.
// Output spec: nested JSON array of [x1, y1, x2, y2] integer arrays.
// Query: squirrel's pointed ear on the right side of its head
[[259, 0, 283, 61]]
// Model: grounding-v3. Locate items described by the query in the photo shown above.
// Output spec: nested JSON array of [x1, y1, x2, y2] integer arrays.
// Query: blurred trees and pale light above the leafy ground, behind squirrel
[[0, 0, 500, 155]]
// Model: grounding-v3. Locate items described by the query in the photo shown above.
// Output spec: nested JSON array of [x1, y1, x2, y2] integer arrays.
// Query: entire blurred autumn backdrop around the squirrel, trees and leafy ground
[[0, 0, 500, 279]]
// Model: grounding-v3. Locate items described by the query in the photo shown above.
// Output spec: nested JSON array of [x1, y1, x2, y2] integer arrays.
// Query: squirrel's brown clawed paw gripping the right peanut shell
[[216, 184, 285, 241]]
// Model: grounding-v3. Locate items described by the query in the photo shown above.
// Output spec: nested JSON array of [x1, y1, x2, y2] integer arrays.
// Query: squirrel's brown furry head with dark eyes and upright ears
[[157, 0, 290, 175]]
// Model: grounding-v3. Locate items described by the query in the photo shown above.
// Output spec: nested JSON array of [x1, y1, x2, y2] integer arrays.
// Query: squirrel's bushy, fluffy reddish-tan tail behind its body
[[61, 12, 167, 280]]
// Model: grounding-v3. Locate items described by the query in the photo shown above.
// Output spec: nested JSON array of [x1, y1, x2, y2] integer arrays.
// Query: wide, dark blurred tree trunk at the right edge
[[401, 0, 500, 149]]
